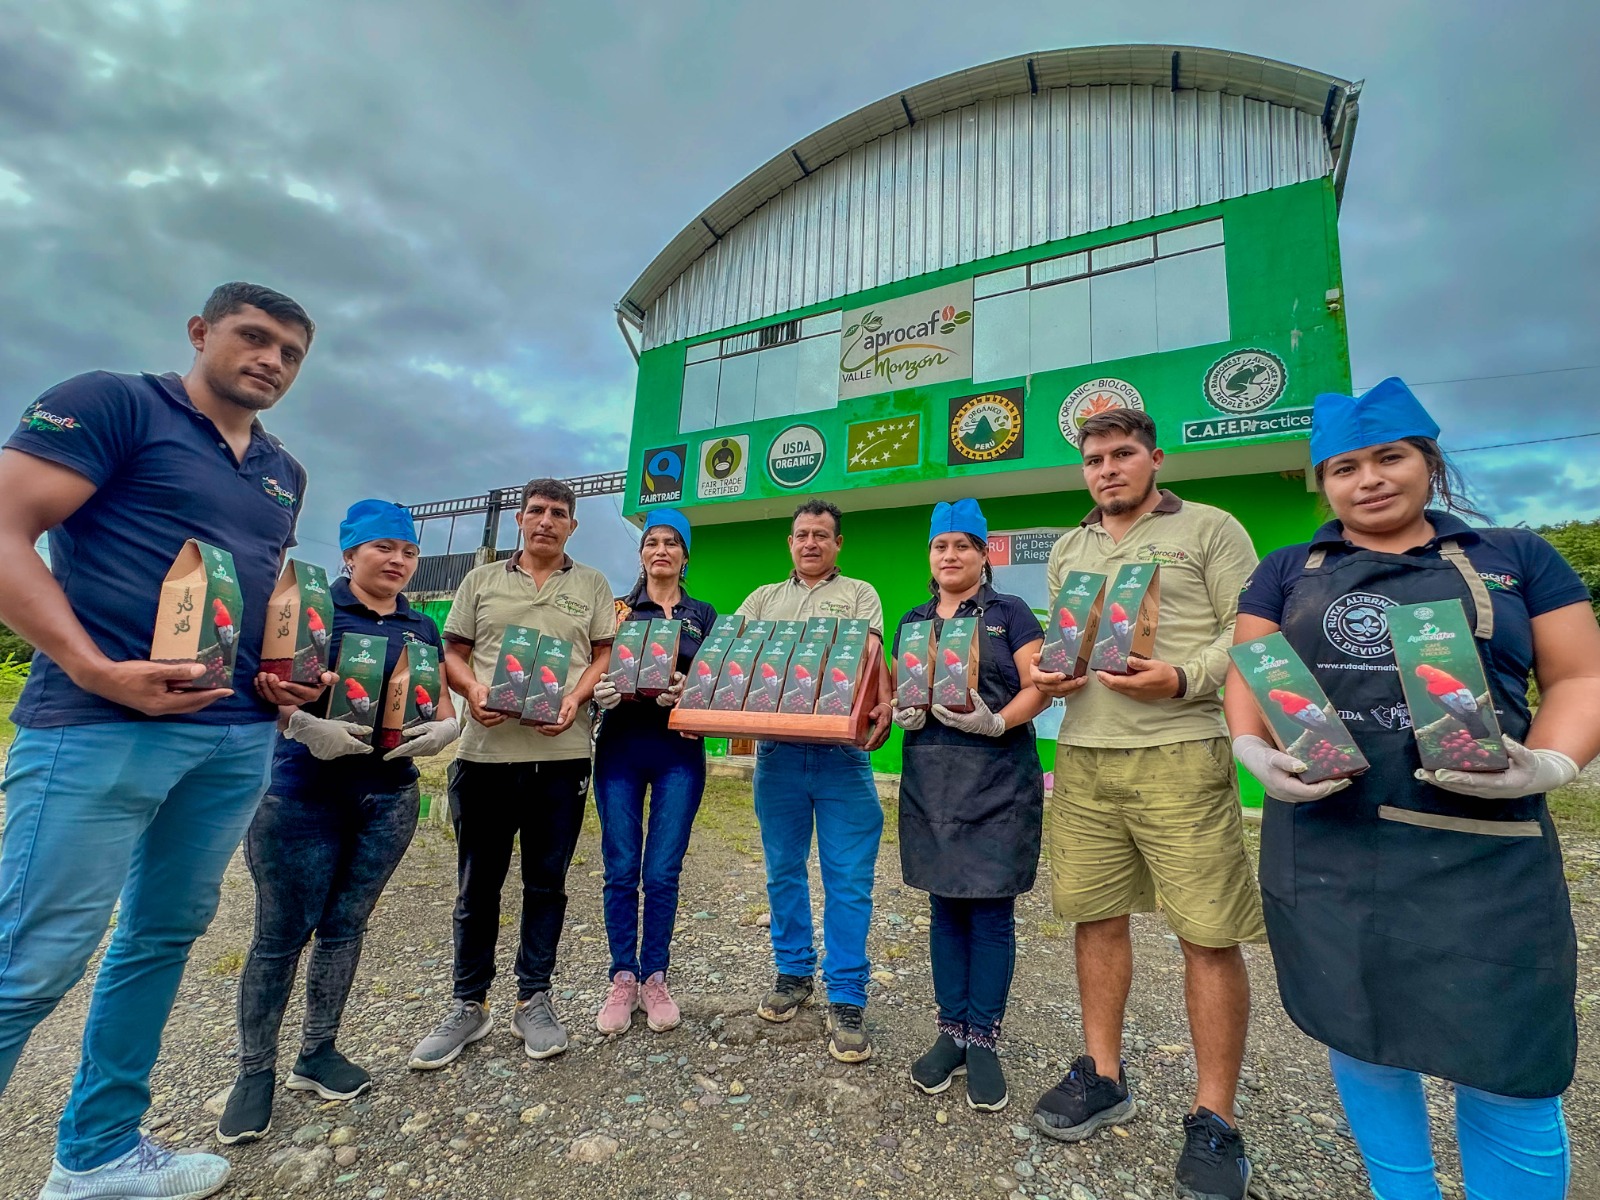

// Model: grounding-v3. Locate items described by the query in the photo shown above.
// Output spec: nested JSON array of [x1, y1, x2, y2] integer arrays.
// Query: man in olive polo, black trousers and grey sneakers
[[411, 478, 616, 1070]]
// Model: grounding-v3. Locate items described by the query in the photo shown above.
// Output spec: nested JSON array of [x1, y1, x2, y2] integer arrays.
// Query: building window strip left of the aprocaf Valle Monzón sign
[[678, 310, 840, 434]]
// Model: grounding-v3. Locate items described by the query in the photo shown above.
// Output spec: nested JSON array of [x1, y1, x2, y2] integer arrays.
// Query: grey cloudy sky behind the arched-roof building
[[0, 0, 1600, 582]]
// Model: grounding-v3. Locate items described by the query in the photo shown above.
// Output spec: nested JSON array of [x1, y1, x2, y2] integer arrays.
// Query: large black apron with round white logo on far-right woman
[[1261, 541, 1578, 1098]]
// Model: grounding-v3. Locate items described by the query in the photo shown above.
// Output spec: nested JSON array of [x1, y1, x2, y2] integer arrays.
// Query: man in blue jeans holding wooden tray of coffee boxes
[[739, 499, 893, 1062]]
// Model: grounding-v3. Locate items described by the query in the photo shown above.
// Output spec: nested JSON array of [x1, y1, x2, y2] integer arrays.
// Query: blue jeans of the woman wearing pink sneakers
[[595, 733, 706, 979]]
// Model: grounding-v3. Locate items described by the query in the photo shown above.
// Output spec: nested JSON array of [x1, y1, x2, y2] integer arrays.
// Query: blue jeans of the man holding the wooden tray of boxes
[[755, 742, 883, 1005]]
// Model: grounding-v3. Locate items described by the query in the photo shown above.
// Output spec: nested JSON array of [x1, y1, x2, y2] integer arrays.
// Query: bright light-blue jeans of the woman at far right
[[1328, 1050, 1571, 1200]]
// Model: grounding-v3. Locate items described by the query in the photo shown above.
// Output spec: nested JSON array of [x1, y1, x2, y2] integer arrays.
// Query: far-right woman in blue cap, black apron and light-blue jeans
[[1226, 379, 1600, 1200]]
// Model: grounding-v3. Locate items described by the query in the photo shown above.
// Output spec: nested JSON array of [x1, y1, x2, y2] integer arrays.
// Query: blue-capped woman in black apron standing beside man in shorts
[[894, 499, 1050, 1112]]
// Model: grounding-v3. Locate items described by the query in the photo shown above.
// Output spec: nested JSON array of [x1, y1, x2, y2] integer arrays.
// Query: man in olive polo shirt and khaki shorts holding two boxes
[[1032, 408, 1266, 1197]]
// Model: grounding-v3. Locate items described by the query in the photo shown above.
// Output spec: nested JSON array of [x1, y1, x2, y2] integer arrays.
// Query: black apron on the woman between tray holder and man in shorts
[[899, 606, 1045, 899]]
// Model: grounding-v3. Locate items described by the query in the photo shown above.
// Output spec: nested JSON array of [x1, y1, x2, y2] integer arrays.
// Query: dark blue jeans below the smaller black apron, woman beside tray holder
[[928, 896, 1016, 1050]]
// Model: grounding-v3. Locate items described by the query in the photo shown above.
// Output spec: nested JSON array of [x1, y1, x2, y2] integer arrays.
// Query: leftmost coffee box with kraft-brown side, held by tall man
[[150, 538, 245, 691]]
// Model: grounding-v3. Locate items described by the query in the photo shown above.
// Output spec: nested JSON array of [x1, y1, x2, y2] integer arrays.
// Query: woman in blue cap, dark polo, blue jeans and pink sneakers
[[595, 509, 717, 1034]]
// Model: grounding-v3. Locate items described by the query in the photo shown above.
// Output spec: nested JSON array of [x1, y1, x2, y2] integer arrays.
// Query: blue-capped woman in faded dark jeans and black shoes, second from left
[[216, 499, 461, 1144]]
